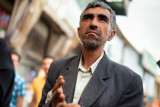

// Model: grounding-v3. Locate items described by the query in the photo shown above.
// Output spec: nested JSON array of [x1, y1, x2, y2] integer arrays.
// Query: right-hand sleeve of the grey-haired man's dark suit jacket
[[116, 75, 143, 107]]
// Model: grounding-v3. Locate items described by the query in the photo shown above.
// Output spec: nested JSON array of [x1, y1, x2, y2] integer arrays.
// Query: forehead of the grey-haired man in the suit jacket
[[82, 7, 111, 18]]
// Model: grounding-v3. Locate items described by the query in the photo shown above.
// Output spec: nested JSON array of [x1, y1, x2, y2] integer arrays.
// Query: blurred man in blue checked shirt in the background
[[10, 51, 26, 107]]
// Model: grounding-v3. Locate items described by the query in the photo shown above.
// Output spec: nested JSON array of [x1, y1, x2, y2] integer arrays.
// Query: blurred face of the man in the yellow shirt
[[42, 58, 53, 74]]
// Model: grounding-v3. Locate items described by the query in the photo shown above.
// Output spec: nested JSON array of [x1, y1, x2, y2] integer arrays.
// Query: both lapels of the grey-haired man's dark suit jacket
[[62, 53, 111, 107]]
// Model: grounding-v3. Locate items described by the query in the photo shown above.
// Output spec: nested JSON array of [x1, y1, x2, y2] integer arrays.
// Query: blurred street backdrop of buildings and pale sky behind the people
[[0, 0, 160, 107]]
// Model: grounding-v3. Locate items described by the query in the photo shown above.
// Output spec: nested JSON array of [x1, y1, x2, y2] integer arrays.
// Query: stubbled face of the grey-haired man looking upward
[[78, 7, 115, 50]]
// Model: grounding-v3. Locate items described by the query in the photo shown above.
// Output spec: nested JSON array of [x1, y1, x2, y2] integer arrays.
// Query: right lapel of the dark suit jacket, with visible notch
[[80, 54, 110, 107]]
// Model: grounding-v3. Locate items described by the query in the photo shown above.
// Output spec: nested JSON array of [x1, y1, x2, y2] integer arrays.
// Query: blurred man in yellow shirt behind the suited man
[[30, 56, 54, 107]]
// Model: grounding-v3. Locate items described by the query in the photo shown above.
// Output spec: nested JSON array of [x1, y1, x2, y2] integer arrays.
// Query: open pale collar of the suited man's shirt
[[78, 52, 104, 74]]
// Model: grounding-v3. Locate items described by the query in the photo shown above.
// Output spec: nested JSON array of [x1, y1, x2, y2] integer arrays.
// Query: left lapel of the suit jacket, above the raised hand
[[61, 55, 80, 103]]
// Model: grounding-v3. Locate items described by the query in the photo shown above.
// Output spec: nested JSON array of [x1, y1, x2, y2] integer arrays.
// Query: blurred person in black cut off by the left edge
[[0, 38, 14, 107]]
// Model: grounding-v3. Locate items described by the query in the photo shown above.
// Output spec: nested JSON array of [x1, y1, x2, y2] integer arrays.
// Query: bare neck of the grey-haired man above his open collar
[[82, 46, 104, 69]]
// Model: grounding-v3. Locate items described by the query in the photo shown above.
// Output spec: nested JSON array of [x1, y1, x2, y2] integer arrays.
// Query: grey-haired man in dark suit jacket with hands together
[[39, 1, 143, 107]]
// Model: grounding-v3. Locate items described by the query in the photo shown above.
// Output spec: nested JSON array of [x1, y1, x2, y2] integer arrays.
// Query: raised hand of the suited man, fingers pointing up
[[52, 76, 67, 107]]
